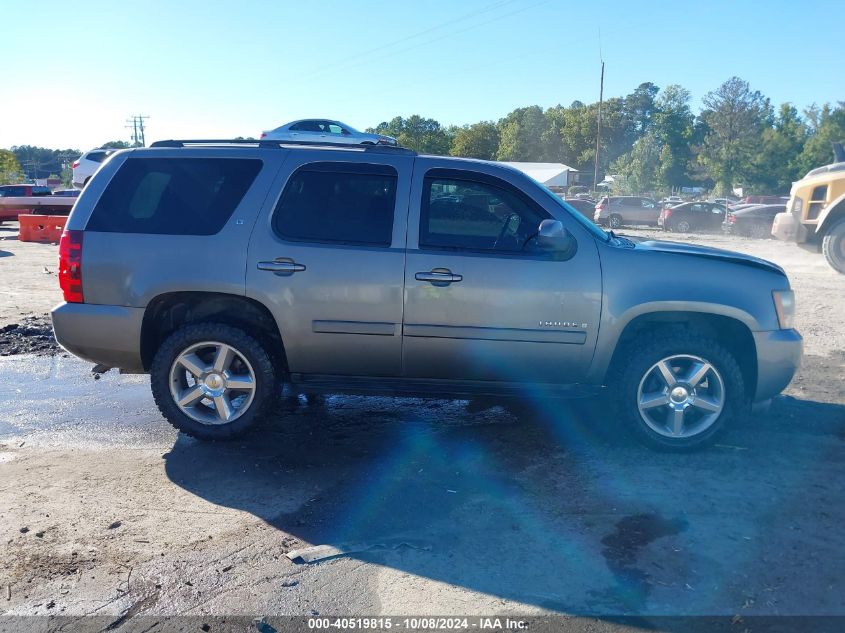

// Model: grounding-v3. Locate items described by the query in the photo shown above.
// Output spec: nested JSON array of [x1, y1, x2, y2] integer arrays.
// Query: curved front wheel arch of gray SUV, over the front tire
[[603, 310, 757, 397]]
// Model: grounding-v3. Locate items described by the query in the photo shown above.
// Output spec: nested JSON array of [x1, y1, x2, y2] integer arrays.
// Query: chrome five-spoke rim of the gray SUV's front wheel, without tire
[[637, 354, 725, 439]]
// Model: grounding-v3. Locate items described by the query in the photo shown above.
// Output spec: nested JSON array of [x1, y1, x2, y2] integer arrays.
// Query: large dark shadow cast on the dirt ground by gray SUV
[[165, 360, 845, 616]]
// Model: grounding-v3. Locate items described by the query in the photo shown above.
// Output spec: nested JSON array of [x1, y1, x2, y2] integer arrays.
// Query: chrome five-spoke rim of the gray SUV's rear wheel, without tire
[[170, 341, 256, 424]]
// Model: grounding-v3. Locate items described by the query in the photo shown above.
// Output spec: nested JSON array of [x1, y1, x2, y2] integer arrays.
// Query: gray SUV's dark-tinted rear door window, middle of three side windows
[[273, 163, 397, 246]]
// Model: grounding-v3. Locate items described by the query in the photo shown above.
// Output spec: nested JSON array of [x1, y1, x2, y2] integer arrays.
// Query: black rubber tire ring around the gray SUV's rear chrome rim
[[150, 323, 278, 440]]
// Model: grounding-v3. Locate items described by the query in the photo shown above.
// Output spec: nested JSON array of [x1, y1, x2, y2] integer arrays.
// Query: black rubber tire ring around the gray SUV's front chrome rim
[[608, 326, 749, 452]]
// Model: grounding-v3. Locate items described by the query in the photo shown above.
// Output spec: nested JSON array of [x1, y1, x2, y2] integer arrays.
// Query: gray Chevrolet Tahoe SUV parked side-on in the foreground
[[52, 141, 802, 450]]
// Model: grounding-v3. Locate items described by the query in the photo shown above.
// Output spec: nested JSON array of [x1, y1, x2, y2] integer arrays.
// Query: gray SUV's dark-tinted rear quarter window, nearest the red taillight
[[87, 158, 261, 235]]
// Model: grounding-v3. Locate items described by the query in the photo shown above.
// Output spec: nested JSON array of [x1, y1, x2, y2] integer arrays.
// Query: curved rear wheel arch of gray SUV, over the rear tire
[[141, 291, 287, 371]]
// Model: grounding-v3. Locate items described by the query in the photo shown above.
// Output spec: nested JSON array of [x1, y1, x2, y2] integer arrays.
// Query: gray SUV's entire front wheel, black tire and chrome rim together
[[609, 327, 748, 452]]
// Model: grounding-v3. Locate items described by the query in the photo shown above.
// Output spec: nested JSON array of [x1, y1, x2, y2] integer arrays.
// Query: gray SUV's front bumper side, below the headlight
[[753, 330, 804, 402]]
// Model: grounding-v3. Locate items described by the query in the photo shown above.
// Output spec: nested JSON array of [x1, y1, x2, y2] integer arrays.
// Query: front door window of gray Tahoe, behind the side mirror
[[420, 178, 547, 252]]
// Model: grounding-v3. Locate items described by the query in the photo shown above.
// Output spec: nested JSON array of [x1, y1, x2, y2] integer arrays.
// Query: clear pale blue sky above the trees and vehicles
[[0, 0, 845, 151]]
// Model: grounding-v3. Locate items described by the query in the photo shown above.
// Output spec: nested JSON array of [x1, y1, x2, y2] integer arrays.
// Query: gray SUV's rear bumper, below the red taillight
[[50, 303, 145, 373]]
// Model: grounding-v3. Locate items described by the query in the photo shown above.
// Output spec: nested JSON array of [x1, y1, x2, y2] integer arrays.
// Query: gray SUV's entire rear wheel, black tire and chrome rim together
[[150, 323, 278, 440]]
